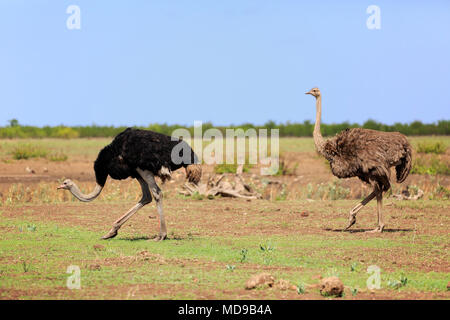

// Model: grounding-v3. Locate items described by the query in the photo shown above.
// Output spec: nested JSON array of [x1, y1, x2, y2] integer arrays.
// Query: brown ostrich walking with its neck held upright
[[306, 88, 412, 232]]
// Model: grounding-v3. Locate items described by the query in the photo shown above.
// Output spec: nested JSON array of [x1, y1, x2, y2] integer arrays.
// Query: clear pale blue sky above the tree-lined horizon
[[0, 0, 450, 126]]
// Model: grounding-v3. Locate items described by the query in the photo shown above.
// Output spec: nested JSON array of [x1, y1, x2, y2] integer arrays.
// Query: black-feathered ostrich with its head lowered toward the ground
[[58, 128, 202, 240]]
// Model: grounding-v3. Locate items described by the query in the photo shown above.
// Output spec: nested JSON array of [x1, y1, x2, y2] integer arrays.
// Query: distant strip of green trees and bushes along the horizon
[[0, 119, 450, 139]]
